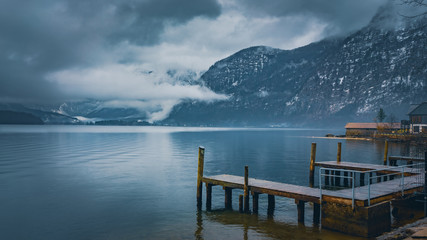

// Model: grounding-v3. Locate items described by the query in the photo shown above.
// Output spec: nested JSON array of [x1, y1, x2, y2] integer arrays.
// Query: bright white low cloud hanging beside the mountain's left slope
[[46, 64, 228, 122]]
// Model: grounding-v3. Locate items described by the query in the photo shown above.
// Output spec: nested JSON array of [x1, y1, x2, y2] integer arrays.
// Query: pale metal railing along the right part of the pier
[[319, 163, 425, 208]]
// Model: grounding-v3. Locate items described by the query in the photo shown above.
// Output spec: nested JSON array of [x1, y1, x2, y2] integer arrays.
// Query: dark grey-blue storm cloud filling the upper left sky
[[0, 0, 220, 101]]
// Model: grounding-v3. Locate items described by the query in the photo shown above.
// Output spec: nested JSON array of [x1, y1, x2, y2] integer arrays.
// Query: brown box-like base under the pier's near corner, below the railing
[[322, 199, 391, 238]]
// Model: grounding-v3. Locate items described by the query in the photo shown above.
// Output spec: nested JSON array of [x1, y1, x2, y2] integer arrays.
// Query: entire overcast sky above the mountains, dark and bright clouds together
[[0, 0, 404, 119]]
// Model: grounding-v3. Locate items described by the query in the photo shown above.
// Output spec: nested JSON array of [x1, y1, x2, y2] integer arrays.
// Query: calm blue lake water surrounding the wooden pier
[[0, 125, 422, 239]]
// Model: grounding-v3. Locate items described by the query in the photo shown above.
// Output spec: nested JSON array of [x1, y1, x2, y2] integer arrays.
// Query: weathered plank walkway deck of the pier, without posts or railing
[[202, 174, 424, 209]]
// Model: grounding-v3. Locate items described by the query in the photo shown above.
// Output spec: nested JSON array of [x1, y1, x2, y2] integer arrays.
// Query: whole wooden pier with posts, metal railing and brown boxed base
[[197, 143, 427, 237]]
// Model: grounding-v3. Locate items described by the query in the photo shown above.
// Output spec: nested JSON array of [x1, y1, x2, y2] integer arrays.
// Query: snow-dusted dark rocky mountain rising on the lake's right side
[[163, 7, 427, 127]]
